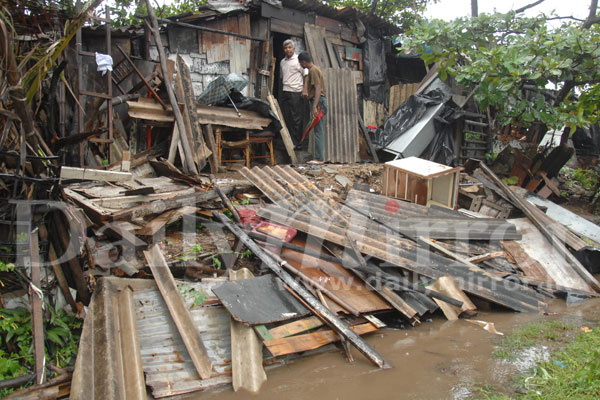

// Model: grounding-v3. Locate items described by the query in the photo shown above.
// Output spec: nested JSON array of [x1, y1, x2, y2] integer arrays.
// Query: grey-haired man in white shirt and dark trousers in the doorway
[[280, 39, 308, 147]]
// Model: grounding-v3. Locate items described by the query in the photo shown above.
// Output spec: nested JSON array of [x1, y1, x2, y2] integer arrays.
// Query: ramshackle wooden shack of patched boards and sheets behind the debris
[[68, 0, 424, 166]]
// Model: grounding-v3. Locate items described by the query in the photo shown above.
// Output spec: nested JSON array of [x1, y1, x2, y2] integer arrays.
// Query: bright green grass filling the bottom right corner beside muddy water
[[477, 327, 600, 400]]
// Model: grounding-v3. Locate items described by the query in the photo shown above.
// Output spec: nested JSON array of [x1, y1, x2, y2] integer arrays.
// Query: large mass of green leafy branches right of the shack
[[407, 12, 600, 131]]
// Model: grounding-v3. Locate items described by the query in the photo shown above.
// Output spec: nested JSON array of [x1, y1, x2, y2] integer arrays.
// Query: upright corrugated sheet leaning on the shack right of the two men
[[323, 68, 358, 163]]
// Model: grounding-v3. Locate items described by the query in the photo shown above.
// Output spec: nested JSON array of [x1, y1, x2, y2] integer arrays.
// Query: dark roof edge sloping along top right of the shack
[[281, 0, 400, 35]]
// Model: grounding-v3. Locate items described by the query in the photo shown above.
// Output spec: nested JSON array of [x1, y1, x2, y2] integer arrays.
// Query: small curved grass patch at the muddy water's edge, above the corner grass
[[493, 321, 575, 360]]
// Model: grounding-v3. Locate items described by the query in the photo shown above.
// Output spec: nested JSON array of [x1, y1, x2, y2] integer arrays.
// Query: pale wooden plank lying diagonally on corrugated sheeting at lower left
[[144, 244, 212, 379]]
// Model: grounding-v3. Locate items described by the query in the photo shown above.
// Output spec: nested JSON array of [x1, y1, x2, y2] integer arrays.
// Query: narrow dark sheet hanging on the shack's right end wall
[[363, 29, 386, 104]]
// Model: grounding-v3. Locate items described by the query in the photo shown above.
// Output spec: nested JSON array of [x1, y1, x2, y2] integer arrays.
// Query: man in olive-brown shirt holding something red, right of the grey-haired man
[[298, 51, 327, 164]]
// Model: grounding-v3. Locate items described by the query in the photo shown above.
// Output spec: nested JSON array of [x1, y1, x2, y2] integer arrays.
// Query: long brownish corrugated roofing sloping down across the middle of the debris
[[240, 166, 545, 311]]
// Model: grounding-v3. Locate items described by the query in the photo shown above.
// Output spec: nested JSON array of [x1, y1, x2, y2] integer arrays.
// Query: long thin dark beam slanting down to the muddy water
[[213, 212, 390, 368]]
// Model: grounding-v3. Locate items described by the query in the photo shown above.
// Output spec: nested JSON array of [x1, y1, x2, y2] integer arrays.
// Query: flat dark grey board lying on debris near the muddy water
[[213, 275, 310, 325]]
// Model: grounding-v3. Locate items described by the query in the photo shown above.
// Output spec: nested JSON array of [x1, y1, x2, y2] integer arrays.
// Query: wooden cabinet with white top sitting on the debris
[[383, 157, 462, 209]]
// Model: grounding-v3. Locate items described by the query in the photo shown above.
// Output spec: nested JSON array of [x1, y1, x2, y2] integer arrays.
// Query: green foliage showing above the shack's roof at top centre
[[324, 0, 437, 31]]
